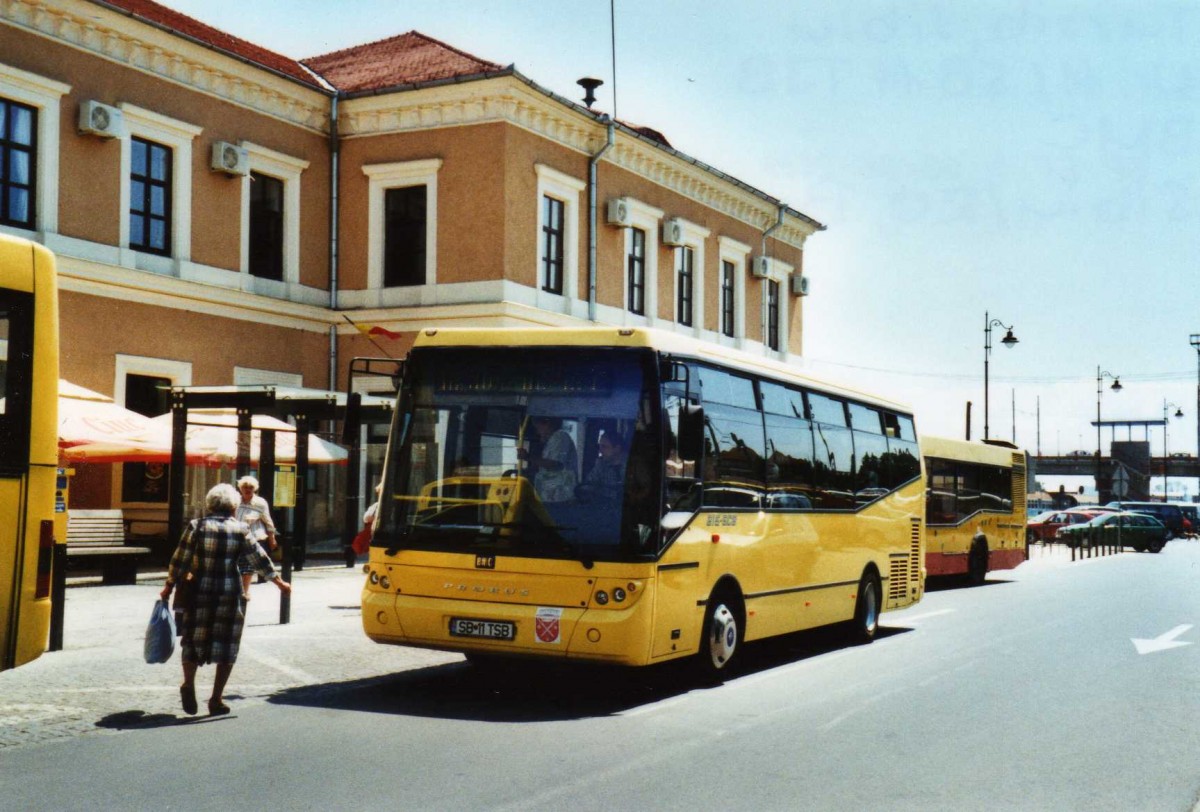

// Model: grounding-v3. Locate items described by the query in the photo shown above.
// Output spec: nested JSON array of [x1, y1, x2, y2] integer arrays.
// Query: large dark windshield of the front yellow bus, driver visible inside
[[373, 348, 661, 561]]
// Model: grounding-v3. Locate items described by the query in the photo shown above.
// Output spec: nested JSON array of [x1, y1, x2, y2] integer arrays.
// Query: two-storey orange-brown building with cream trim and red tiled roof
[[0, 0, 823, 509]]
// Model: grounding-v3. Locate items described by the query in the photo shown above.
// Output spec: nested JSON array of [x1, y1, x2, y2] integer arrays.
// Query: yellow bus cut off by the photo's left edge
[[0, 235, 59, 669]]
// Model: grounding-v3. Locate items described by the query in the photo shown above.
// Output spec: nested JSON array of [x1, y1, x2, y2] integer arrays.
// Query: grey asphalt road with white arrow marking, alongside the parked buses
[[0, 542, 1200, 812]]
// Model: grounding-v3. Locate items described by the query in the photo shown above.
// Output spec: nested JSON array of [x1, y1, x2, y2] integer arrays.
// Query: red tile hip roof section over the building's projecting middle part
[[302, 31, 505, 94]]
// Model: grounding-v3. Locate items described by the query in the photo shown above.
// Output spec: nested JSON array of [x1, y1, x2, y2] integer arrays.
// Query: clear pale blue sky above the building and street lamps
[[167, 0, 1200, 492]]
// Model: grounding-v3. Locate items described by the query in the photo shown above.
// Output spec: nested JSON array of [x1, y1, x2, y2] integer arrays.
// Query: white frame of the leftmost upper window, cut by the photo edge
[[0, 62, 71, 236]]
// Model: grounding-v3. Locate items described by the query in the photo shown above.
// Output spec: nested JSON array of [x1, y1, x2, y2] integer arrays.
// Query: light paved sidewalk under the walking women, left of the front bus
[[0, 565, 461, 751]]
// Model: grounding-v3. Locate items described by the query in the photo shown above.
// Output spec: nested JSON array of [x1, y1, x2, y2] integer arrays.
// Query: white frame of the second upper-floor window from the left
[[118, 102, 204, 268]]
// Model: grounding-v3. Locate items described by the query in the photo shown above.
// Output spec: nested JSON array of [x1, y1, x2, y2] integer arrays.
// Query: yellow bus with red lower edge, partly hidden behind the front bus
[[920, 437, 1026, 584]]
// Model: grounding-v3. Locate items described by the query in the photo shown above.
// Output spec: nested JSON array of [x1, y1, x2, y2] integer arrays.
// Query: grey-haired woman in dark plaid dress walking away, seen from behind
[[162, 485, 292, 716]]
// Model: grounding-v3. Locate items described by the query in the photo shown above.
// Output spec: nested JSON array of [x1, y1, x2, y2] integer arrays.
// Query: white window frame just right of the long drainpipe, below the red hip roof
[[362, 158, 442, 295]]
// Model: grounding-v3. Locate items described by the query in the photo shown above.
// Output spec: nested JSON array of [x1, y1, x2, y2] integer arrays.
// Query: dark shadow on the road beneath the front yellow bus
[[269, 627, 910, 722]]
